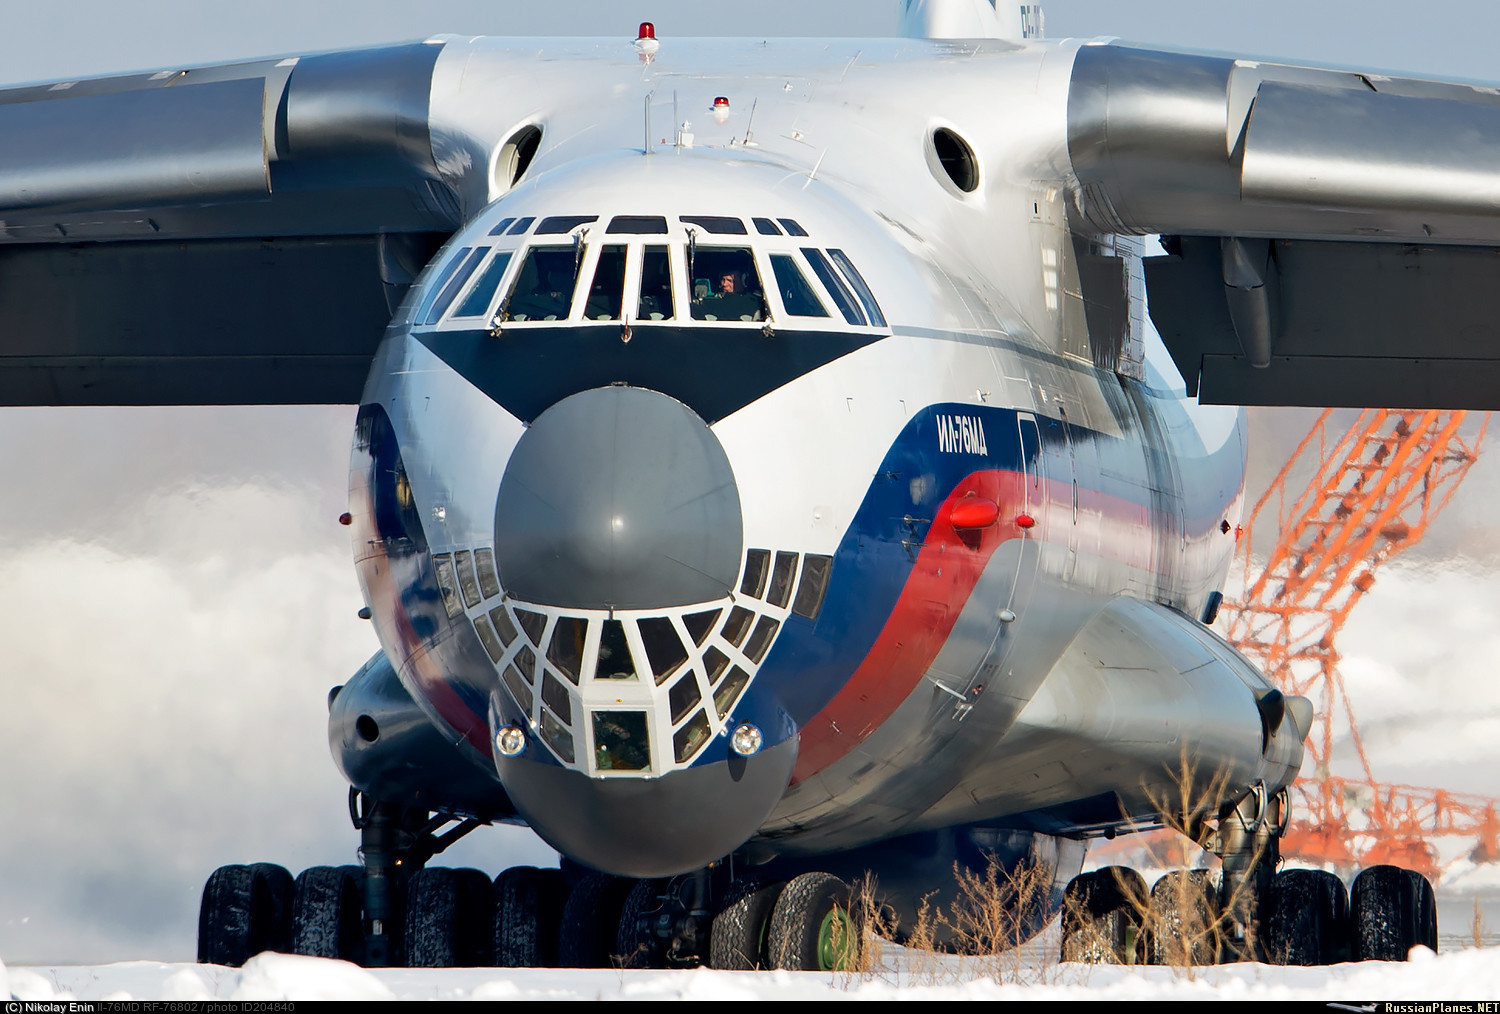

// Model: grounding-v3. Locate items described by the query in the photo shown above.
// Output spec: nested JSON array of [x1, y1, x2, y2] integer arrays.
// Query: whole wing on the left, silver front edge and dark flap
[[0, 42, 461, 405]]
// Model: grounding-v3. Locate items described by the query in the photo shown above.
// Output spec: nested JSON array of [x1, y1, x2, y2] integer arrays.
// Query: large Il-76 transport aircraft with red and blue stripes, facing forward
[[0, 0, 1500, 969]]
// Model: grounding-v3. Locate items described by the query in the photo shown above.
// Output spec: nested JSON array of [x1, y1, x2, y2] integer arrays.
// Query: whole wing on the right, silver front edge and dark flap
[[1068, 44, 1500, 408]]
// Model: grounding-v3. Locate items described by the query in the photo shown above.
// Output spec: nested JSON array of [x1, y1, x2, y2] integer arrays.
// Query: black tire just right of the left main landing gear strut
[[407, 867, 495, 968]]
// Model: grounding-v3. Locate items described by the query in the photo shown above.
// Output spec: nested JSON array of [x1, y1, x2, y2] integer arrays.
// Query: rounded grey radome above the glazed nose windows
[[495, 386, 744, 609]]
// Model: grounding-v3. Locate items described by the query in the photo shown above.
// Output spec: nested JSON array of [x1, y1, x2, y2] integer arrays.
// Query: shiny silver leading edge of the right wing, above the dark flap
[[1068, 45, 1500, 245]]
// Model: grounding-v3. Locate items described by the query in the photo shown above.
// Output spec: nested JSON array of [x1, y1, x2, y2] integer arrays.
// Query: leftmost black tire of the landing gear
[[198, 863, 293, 968]]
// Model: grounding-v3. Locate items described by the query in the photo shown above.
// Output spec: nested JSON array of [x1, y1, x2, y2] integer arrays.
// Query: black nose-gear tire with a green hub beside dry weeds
[[767, 873, 861, 972]]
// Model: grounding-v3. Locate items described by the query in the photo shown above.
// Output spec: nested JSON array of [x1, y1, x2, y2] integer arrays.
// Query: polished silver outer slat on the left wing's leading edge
[[0, 78, 270, 212]]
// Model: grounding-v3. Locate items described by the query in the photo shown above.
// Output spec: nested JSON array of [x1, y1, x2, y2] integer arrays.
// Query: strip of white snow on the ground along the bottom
[[0, 948, 1500, 1002]]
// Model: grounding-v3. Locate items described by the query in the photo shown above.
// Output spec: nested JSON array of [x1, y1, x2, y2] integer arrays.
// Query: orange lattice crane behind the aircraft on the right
[[1224, 410, 1500, 878]]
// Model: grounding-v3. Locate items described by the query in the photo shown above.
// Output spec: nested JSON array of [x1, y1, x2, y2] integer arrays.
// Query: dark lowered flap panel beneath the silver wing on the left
[[0, 237, 425, 405]]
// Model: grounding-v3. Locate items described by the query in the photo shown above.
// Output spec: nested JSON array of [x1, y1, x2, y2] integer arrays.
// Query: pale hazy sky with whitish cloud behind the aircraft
[[0, 0, 1500, 963]]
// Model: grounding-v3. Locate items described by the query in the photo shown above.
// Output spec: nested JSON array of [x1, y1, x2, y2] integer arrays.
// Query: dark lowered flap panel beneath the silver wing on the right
[[1146, 237, 1500, 410]]
